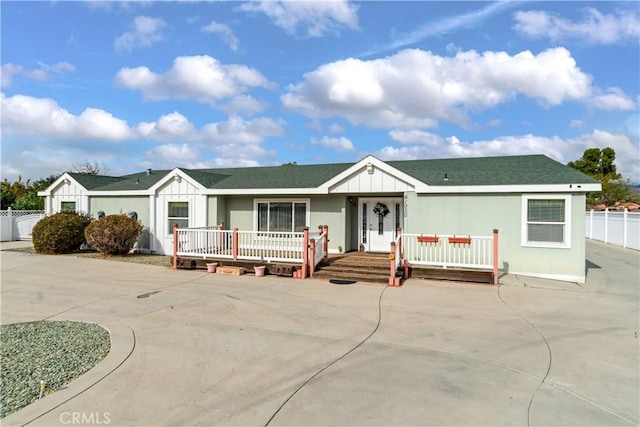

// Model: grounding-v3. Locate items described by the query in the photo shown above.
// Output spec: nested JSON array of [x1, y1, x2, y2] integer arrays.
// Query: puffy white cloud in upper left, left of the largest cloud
[[114, 55, 274, 105]]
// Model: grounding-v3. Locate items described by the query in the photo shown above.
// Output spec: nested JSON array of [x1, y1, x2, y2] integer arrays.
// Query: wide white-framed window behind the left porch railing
[[256, 200, 309, 232]]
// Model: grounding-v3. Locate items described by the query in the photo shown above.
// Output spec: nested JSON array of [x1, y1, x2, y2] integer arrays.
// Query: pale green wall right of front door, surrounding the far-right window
[[404, 192, 585, 281]]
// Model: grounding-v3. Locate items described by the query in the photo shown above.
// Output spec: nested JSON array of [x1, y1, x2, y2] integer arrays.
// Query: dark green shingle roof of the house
[[76, 155, 598, 191]]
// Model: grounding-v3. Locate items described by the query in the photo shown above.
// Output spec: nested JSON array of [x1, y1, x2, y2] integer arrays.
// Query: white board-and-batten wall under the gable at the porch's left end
[[151, 179, 208, 255]]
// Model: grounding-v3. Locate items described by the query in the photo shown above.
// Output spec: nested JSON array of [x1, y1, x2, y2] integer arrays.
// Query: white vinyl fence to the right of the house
[[585, 209, 640, 250]]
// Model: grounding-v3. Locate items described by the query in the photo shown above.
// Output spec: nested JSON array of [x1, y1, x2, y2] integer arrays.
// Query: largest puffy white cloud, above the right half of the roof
[[281, 48, 633, 128]]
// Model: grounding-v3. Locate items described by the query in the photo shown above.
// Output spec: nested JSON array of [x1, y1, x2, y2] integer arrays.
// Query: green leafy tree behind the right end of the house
[[567, 147, 638, 208]]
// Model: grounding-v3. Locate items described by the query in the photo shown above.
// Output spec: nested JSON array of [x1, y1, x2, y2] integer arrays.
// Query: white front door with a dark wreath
[[358, 197, 403, 252]]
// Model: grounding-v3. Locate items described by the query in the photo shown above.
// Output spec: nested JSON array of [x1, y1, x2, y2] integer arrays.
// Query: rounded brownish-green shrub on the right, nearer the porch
[[84, 215, 142, 255]]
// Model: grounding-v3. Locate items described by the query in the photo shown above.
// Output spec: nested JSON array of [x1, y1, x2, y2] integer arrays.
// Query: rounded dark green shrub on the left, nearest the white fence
[[31, 211, 91, 254]]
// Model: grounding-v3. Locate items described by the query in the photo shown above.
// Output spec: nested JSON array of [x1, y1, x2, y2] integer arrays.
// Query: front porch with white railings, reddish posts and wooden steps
[[173, 226, 499, 286]]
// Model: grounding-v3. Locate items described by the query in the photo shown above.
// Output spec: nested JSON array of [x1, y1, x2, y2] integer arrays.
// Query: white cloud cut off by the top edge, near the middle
[[239, 0, 358, 37]]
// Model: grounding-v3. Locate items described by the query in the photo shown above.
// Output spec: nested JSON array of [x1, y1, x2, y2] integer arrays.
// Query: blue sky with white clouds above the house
[[0, 1, 640, 182]]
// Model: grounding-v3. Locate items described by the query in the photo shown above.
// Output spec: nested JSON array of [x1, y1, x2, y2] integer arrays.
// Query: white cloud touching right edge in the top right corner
[[514, 7, 640, 44]]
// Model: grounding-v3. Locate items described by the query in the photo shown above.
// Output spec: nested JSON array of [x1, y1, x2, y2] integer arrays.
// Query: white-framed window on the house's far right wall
[[522, 195, 571, 247]]
